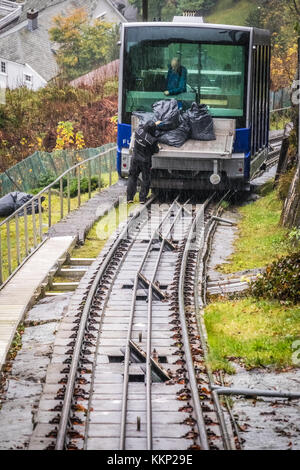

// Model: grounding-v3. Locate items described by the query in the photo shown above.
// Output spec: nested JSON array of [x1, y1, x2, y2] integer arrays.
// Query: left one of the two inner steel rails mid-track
[[119, 197, 182, 450]]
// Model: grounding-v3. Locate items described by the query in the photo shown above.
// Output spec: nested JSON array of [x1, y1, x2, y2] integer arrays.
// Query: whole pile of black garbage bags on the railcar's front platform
[[133, 99, 216, 147]]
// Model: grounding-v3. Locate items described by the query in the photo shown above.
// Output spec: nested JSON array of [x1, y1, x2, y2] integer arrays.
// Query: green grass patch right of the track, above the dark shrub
[[218, 190, 289, 274]]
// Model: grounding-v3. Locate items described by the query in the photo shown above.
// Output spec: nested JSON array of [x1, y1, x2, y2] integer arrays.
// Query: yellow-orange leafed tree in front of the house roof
[[49, 9, 112, 79]]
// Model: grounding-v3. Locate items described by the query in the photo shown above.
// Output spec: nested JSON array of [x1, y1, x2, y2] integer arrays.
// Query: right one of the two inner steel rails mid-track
[[146, 200, 185, 450]]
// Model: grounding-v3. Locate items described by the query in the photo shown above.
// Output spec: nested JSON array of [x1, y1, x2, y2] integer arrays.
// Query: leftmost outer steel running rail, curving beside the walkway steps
[[55, 197, 154, 450]]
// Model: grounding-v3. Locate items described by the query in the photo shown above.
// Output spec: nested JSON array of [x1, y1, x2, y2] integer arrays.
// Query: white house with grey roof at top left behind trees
[[0, 0, 127, 90]]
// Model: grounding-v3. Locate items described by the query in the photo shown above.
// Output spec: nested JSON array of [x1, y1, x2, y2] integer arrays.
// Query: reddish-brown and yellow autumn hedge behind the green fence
[[0, 84, 117, 172]]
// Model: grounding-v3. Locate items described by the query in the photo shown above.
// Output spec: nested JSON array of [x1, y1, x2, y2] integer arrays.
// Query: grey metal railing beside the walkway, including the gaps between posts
[[0, 144, 117, 286]]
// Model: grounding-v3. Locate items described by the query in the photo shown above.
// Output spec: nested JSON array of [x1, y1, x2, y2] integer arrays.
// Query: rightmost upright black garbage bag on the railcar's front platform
[[184, 103, 216, 140]]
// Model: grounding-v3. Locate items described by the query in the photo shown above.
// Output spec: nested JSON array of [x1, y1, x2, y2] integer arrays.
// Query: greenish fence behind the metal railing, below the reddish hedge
[[0, 144, 115, 196]]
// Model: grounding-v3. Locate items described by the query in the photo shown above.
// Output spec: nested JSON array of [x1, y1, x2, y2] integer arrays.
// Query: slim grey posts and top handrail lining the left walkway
[[0, 146, 117, 288]]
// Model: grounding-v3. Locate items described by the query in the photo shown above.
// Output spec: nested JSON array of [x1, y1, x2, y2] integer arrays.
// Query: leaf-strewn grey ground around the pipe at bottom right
[[230, 368, 300, 450]]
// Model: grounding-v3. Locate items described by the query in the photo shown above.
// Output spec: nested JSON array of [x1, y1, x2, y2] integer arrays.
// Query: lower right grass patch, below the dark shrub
[[204, 297, 300, 373]]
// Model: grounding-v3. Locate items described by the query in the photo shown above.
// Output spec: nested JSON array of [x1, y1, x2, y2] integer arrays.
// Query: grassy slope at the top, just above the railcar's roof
[[205, 0, 256, 26]]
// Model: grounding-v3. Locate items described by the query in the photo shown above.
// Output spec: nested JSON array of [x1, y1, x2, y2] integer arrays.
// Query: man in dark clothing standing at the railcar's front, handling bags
[[127, 121, 159, 204]]
